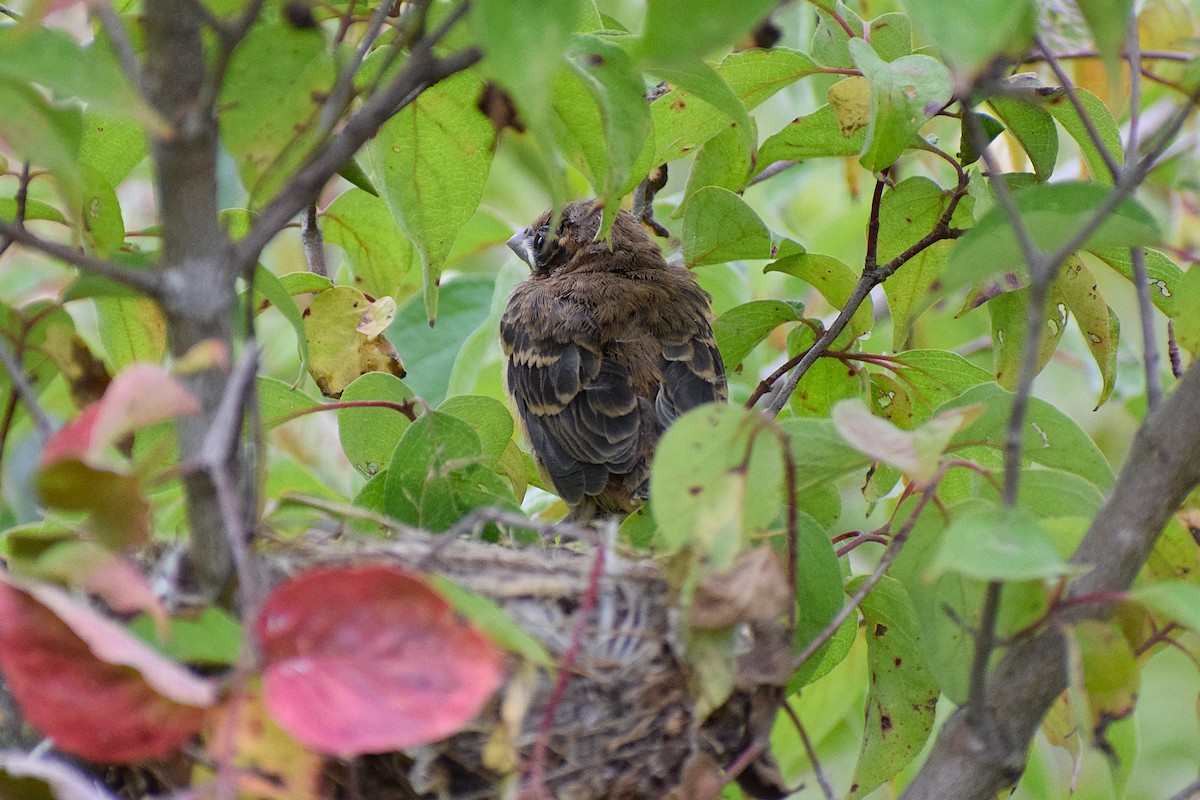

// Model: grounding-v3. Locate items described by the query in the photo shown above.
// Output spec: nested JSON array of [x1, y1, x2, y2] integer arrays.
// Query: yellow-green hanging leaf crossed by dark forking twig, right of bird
[[864, 178, 971, 350]]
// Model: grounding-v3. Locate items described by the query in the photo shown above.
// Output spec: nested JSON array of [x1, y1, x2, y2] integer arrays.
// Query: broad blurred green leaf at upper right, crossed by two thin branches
[[946, 184, 1162, 285]]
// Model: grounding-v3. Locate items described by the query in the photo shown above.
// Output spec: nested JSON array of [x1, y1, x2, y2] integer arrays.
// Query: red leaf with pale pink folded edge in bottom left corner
[[0, 582, 216, 764]]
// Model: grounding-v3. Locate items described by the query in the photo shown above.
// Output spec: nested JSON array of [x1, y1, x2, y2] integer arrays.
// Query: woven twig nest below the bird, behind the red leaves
[[269, 527, 788, 800]]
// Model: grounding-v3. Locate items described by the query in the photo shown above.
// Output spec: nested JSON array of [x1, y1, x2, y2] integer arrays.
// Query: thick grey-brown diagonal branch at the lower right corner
[[904, 357, 1200, 800]]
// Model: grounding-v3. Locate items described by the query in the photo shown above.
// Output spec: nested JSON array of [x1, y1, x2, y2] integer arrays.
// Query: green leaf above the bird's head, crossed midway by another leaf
[[650, 47, 821, 164]]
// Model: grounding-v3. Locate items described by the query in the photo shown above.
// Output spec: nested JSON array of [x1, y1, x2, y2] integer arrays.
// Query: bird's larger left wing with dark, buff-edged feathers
[[500, 284, 641, 505]]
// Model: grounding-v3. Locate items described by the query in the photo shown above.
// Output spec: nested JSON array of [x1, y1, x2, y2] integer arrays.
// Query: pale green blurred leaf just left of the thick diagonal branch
[[926, 506, 1087, 581]]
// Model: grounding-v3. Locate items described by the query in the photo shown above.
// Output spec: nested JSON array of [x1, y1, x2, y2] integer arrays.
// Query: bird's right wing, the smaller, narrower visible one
[[654, 281, 728, 428]]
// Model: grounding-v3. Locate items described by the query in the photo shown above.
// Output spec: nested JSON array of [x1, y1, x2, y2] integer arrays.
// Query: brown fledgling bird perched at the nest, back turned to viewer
[[500, 201, 727, 522]]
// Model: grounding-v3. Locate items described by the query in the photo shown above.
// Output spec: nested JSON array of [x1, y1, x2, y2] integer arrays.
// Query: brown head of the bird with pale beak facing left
[[508, 200, 662, 275]]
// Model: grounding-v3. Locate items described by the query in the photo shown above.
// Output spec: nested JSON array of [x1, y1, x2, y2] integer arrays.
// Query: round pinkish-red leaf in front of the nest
[[257, 566, 504, 757]]
